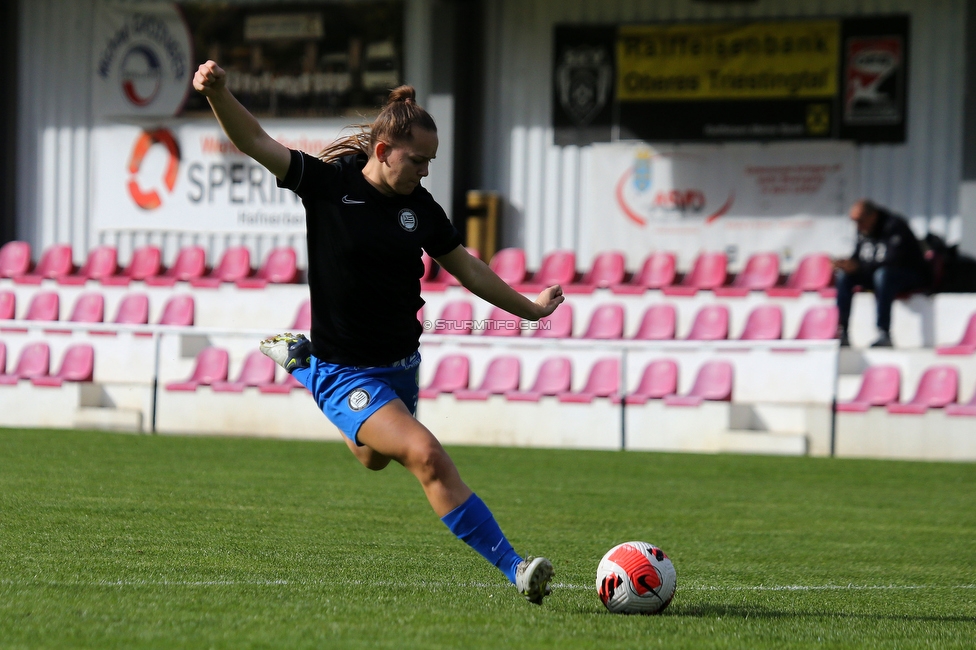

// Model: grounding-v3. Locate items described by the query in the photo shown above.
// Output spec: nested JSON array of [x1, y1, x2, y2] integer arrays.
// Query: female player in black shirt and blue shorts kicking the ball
[[193, 61, 563, 605]]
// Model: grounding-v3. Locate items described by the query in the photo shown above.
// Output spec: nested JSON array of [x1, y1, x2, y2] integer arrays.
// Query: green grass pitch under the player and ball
[[0, 430, 976, 649]]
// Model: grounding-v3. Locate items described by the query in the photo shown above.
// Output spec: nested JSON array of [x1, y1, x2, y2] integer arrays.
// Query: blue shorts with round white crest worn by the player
[[291, 351, 420, 446]]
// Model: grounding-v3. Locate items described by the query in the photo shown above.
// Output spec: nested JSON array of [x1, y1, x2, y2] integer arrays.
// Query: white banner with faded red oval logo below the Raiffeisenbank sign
[[580, 142, 858, 268]]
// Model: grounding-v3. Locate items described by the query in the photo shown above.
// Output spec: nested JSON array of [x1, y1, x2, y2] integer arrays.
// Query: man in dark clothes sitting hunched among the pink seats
[[834, 199, 927, 348]]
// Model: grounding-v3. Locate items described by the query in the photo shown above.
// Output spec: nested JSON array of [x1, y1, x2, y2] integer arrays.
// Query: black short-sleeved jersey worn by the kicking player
[[278, 151, 461, 366]]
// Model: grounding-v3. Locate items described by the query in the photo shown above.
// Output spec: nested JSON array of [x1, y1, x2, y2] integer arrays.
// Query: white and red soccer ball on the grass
[[596, 542, 677, 614]]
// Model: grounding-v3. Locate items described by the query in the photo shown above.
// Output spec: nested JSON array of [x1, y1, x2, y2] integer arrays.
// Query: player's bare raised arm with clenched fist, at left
[[193, 61, 291, 178]]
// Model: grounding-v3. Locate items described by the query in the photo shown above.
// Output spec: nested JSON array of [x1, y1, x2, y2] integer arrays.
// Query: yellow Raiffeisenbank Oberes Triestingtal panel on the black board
[[617, 20, 840, 102]]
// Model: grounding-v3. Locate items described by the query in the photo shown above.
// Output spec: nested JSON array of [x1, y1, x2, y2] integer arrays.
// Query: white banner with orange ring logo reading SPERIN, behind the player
[[92, 120, 345, 233]]
